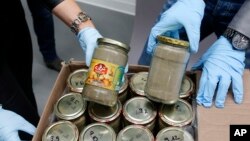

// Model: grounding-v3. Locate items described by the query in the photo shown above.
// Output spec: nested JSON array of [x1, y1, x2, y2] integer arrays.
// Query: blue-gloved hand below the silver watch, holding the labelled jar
[[77, 27, 102, 66]]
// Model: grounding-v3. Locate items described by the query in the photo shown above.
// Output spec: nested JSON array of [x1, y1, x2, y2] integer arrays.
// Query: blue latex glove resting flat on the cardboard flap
[[192, 36, 245, 108]]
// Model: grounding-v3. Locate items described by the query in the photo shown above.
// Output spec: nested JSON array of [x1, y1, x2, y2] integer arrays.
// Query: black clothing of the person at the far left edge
[[0, 0, 39, 140]]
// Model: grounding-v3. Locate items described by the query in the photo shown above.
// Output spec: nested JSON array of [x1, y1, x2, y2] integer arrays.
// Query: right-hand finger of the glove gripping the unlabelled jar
[[184, 24, 200, 53]]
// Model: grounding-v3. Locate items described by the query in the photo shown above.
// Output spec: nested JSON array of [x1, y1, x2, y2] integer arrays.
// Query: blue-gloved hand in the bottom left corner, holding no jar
[[0, 105, 36, 141]]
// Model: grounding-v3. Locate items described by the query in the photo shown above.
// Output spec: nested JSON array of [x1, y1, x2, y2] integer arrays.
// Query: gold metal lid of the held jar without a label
[[157, 35, 189, 48]]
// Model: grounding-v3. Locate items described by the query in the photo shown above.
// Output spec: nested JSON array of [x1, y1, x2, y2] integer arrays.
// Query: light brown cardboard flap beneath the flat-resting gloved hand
[[196, 70, 250, 141]]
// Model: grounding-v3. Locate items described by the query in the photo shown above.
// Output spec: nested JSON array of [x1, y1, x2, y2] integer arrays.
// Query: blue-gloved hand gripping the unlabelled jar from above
[[147, 0, 205, 54]]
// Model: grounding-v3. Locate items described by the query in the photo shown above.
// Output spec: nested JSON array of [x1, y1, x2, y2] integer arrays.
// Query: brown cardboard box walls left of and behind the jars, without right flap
[[32, 60, 151, 141]]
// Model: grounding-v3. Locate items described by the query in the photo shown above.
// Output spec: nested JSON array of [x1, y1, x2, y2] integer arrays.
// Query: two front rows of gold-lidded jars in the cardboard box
[[43, 93, 194, 141]]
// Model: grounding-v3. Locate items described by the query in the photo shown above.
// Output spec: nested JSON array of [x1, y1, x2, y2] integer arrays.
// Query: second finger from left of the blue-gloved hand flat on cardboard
[[215, 72, 231, 108]]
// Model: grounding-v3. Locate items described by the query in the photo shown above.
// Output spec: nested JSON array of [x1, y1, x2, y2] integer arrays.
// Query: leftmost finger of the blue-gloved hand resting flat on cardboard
[[202, 62, 219, 107]]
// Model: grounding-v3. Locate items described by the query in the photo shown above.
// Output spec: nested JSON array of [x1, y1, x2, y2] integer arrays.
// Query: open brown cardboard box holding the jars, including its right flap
[[32, 60, 250, 141]]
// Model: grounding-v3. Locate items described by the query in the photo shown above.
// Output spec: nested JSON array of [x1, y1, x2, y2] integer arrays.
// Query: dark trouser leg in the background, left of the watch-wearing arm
[[27, 0, 58, 62]]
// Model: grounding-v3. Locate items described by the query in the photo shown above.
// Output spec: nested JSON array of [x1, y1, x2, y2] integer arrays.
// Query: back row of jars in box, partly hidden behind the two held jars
[[67, 69, 194, 104]]
